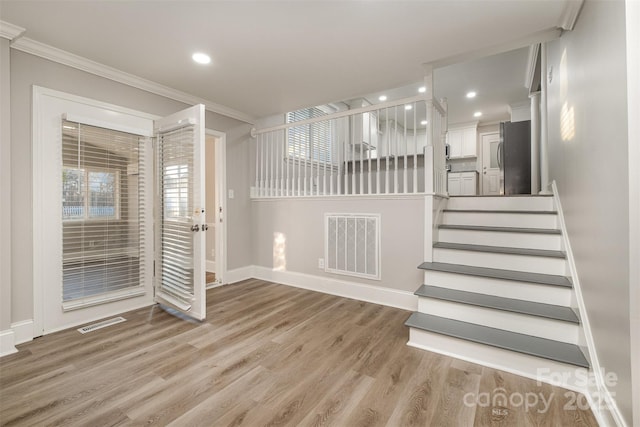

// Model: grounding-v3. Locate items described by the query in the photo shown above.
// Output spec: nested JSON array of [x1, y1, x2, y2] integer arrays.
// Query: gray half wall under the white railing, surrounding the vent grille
[[251, 197, 424, 292]]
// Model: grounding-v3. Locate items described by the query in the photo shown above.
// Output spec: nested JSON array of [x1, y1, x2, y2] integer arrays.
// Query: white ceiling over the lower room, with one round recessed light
[[0, 0, 576, 118]]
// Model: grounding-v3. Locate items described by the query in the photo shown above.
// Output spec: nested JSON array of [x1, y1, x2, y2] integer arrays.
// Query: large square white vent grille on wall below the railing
[[324, 213, 380, 280]]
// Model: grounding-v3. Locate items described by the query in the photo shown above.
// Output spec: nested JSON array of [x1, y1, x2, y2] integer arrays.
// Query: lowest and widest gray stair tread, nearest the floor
[[405, 312, 589, 368]]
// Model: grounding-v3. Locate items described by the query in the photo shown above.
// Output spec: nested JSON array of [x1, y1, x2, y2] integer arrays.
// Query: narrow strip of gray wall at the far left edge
[[0, 37, 11, 331]]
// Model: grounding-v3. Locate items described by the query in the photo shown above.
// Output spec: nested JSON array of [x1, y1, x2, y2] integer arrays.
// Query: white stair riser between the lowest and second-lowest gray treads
[[418, 297, 579, 344]]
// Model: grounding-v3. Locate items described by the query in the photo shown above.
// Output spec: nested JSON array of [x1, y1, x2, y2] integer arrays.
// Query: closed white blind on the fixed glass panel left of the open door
[[62, 120, 145, 303]]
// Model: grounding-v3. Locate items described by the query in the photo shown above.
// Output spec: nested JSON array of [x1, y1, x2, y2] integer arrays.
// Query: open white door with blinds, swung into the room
[[154, 105, 207, 320]]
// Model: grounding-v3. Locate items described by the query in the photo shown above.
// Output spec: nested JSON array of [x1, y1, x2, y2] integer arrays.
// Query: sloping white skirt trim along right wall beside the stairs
[[551, 180, 626, 426]]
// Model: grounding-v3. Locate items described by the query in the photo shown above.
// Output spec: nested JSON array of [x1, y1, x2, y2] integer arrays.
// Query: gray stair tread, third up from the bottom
[[418, 262, 573, 288]]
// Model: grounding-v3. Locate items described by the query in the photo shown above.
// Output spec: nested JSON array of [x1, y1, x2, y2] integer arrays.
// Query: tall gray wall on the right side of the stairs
[[548, 1, 637, 425]]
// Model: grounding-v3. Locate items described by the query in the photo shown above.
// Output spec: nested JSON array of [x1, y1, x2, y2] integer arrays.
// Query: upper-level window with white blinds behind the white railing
[[287, 106, 332, 163]]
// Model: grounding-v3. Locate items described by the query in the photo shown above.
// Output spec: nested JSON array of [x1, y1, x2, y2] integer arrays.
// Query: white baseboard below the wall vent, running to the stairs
[[252, 265, 418, 311]]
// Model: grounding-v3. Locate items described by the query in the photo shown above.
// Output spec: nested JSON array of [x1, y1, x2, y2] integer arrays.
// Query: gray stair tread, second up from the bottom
[[415, 285, 580, 324]]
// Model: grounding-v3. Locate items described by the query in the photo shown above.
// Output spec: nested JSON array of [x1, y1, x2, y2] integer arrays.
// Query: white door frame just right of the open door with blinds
[[204, 126, 227, 289]]
